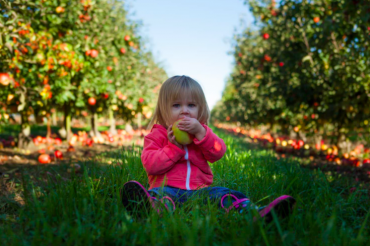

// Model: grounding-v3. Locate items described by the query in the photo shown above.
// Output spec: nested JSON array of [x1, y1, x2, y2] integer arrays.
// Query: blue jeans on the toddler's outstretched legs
[[149, 186, 251, 211]]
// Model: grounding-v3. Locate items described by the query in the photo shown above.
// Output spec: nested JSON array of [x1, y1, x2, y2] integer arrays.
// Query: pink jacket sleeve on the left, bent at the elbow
[[141, 134, 185, 175]]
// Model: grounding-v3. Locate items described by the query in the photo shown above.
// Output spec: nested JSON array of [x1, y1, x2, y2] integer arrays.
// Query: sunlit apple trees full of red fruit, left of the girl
[[0, 0, 167, 147]]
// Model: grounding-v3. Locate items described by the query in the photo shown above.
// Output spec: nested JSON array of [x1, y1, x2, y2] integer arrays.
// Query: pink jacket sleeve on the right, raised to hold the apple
[[193, 125, 226, 163]]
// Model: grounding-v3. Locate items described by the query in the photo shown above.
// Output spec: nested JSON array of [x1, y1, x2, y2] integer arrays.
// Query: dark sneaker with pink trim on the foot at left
[[120, 181, 175, 214]]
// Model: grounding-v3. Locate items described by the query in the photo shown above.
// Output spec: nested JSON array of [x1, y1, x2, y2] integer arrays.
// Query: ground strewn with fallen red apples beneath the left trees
[[0, 122, 147, 205]]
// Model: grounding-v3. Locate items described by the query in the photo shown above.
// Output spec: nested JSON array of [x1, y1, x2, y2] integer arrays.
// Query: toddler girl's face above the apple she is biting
[[170, 94, 199, 125]]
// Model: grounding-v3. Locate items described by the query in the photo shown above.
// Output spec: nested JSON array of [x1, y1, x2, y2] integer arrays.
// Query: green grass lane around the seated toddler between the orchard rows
[[0, 126, 370, 245]]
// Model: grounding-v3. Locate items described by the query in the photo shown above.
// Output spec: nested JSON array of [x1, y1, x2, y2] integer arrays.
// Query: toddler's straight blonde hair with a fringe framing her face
[[147, 75, 210, 130]]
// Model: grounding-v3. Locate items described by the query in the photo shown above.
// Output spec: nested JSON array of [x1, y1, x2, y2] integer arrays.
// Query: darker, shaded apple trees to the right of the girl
[[213, 0, 370, 151]]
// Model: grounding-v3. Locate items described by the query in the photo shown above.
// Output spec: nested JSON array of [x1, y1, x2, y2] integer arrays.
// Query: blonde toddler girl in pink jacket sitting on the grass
[[121, 76, 295, 222]]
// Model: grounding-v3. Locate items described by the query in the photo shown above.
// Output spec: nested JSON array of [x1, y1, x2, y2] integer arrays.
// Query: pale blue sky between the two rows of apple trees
[[126, 0, 253, 109]]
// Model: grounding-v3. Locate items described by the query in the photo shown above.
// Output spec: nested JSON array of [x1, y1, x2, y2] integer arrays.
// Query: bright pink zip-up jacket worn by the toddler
[[141, 124, 226, 190]]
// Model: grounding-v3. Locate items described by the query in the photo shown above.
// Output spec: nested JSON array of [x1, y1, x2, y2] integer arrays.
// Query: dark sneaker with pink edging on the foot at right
[[254, 195, 296, 223]]
